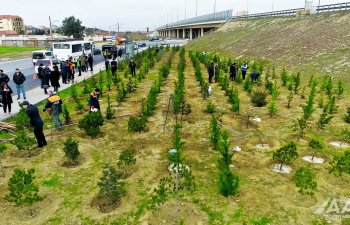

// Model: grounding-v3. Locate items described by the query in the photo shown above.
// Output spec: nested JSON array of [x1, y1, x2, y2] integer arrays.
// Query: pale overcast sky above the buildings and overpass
[[0, 0, 348, 31]]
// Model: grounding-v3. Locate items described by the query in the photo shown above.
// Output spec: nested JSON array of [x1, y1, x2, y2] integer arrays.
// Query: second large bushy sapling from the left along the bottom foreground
[[98, 165, 126, 201]]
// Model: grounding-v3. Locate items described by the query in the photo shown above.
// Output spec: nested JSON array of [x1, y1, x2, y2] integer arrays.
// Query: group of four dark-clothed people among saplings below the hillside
[[208, 61, 260, 83]]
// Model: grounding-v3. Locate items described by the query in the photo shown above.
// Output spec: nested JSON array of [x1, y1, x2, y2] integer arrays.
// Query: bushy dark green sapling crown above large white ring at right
[[273, 142, 299, 170]]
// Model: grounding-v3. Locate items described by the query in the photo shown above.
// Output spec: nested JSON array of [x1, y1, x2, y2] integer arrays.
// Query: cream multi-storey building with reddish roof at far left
[[0, 15, 25, 34]]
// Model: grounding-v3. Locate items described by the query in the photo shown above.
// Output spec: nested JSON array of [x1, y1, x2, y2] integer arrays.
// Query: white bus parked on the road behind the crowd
[[52, 41, 94, 62]]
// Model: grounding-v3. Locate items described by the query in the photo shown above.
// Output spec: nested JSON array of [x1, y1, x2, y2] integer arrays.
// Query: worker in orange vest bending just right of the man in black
[[43, 91, 62, 130]]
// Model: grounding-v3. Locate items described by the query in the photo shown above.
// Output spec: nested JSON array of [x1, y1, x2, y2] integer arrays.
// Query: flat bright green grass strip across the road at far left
[[0, 46, 43, 59]]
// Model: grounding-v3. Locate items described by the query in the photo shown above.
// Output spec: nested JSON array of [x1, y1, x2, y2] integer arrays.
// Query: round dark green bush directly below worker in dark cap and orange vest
[[79, 111, 104, 137]]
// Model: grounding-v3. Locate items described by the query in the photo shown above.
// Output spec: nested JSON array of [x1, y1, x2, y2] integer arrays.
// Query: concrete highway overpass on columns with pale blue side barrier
[[157, 10, 232, 40]]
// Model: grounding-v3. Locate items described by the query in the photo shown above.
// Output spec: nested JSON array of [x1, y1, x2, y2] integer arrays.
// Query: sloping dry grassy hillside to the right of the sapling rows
[[188, 12, 350, 84]]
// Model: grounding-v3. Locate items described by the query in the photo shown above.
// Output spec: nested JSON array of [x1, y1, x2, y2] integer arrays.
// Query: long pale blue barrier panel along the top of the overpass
[[157, 9, 233, 30]]
